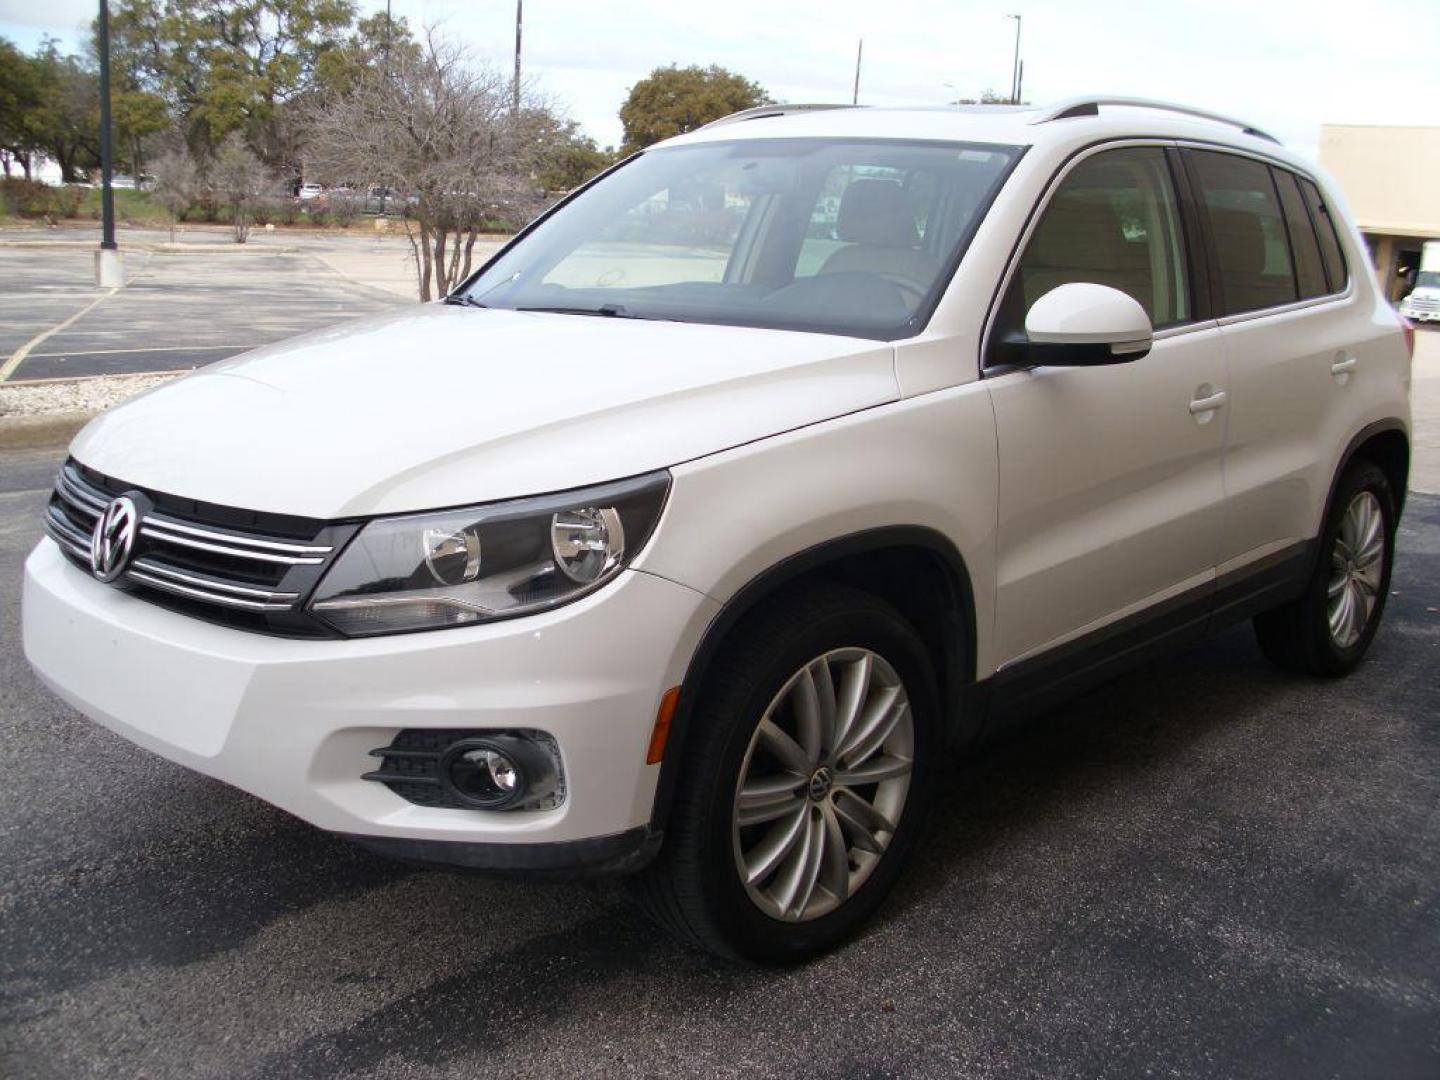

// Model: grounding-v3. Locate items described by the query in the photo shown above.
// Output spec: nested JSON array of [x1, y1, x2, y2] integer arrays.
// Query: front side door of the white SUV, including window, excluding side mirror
[[986, 145, 1225, 664]]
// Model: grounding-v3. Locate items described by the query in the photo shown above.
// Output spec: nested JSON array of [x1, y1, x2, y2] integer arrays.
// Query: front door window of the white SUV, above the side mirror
[[998, 147, 1191, 338]]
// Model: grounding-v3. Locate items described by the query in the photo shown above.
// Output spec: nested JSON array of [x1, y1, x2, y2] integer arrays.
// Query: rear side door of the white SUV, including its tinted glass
[[1184, 150, 1347, 573]]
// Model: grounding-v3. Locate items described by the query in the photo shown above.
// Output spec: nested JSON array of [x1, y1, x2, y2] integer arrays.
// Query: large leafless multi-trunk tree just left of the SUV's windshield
[[307, 30, 547, 301]]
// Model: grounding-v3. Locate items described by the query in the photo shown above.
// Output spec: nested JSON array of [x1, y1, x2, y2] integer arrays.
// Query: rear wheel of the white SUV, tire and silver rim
[[1254, 459, 1395, 678]]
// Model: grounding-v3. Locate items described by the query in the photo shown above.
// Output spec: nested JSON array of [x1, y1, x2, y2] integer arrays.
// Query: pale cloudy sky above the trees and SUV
[[0, 0, 1440, 157]]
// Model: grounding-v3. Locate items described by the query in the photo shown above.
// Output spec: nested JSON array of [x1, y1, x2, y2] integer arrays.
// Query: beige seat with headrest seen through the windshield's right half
[[819, 180, 940, 292]]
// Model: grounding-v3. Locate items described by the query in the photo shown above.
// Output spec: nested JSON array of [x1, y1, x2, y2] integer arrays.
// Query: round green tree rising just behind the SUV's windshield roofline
[[621, 65, 770, 154]]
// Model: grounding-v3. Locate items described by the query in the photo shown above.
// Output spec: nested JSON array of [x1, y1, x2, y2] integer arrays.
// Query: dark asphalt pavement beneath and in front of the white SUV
[[0, 440, 1440, 1080]]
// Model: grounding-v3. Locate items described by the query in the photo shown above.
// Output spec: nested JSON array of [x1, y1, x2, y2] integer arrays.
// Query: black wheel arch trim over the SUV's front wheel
[[651, 526, 984, 832]]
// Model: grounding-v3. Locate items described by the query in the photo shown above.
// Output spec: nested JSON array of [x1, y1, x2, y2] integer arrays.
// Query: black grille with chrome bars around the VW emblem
[[45, 461, 354, 634]]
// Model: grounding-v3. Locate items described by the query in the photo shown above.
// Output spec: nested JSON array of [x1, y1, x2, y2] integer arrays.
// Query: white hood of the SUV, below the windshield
[[72, 304, 899, 518]]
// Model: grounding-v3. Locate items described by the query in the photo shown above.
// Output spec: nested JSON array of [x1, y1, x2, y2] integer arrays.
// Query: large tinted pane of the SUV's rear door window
[[1189, 151, 1296, 315]]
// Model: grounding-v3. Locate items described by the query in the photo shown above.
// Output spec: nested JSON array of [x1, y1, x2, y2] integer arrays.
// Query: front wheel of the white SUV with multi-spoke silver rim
[[631, 586, 942, 965]]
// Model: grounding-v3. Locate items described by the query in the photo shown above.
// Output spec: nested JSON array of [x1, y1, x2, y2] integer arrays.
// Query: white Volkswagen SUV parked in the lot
[[24, 99, 1410, 962]]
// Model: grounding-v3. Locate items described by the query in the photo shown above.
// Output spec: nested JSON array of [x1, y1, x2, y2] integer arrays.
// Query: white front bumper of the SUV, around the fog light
[[23, 540, 717, 870]]
